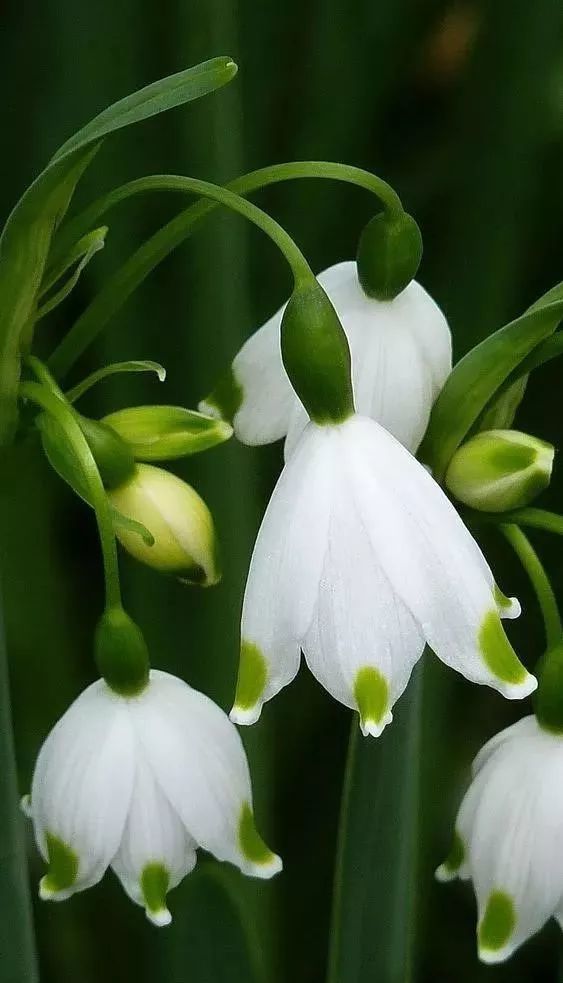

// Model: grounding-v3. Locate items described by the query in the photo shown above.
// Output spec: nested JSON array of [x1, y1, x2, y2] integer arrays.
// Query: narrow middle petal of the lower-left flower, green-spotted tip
[[111, 744, 196, 925]]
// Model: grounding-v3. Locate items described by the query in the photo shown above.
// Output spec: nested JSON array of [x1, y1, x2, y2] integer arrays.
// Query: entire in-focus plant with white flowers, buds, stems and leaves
[[0, 52, 563, 962]]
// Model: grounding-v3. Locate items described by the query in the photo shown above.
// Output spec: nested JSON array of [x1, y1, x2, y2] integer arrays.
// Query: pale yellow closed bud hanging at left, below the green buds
[[108, 464, 221, 587]]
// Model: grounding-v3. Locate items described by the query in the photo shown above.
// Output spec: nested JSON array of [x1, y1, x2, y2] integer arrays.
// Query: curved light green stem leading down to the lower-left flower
[[20, 380, 121, 608]]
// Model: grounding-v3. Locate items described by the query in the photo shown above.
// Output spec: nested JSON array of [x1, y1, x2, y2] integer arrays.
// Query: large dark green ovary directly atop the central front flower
[[281, 281, 354, 424]]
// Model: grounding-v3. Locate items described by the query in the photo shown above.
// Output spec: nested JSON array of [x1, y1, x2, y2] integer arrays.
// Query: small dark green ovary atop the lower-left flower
[[94, 608, 150, 696]]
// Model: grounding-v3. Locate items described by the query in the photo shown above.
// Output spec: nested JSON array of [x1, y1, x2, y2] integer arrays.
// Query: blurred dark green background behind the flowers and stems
[[0, 0, 563, 983]]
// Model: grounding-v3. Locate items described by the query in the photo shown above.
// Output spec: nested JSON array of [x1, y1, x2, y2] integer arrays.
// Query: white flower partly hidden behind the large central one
[[199, 262, 452, 457]]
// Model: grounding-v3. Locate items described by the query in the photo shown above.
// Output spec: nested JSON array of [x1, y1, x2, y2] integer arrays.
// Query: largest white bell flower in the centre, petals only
[[231, 415, 537, 735]]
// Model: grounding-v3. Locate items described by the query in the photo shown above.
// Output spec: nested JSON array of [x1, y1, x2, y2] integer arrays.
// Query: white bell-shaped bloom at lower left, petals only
[[26, 669, 281, 925]]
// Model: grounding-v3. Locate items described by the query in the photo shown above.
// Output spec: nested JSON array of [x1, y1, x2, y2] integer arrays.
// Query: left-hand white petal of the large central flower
[[231, 424, 336, 723]]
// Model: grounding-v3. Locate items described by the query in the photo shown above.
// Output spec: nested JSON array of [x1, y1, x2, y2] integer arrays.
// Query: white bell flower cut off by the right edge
[[436, 716, 563, 963]]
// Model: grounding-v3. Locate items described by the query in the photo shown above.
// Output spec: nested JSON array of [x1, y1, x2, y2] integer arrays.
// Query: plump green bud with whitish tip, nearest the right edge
[[446, 430, 555, 512]]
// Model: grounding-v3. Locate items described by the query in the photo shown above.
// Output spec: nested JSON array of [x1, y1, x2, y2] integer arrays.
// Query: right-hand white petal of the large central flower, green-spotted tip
[[348, 416, 537, 699]]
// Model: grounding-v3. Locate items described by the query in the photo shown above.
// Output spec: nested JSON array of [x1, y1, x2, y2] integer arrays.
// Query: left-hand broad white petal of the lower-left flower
[[31, 680, 134, 900]]
